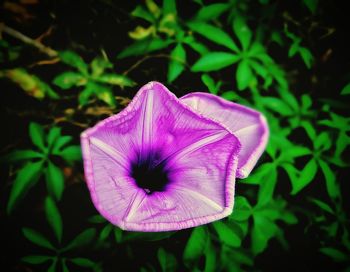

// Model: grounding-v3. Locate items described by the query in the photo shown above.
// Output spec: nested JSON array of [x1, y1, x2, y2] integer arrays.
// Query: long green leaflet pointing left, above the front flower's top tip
[[117, 37, 173, 59]]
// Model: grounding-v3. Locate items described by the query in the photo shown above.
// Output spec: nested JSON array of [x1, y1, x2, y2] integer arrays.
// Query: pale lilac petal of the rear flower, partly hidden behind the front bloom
[[180, 92, 269, 178]]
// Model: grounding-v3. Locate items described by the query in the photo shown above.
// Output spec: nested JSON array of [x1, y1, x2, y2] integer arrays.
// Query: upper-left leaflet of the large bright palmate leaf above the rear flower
[[187, 21, 239, 52]]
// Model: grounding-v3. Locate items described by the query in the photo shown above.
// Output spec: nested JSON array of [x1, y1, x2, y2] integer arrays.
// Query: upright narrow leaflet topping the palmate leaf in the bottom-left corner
[[45, 197, 63, 243]]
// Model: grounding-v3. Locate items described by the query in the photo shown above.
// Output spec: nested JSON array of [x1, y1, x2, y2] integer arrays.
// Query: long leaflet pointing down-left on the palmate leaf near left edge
[[7, 161, 43, 213]]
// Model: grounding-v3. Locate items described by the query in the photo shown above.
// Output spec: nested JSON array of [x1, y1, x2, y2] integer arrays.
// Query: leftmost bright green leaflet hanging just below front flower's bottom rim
[[182, 226, 208, 266]]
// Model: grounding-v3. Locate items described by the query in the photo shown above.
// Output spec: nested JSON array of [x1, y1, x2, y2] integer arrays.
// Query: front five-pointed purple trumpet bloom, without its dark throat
[[81, 82, 240, 231]]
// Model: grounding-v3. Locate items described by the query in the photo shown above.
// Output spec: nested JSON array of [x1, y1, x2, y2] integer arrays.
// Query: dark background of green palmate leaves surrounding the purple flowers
[[0, 0, 350, 271]]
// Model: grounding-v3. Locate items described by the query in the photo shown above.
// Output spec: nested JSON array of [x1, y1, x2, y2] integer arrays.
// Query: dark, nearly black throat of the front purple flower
[[131, 154, 169, 194]]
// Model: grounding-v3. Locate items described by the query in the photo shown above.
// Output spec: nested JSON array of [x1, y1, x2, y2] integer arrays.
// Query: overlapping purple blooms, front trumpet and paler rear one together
[[81, 82, 268, 231]]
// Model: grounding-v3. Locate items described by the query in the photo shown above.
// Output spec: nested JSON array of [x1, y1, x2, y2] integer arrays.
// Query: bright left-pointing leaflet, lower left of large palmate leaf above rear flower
[[191, 52, 240, 72]]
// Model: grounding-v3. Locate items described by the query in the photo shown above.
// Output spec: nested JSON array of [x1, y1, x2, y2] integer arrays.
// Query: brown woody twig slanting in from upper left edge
[[0, 24, 58, 58]]
